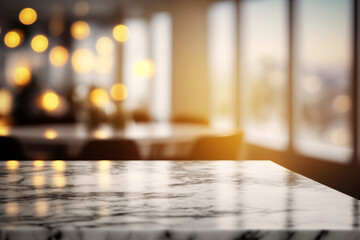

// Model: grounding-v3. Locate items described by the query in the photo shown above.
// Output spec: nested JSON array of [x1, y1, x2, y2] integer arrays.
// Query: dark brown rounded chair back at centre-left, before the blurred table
[[79, 139, 141, 160]]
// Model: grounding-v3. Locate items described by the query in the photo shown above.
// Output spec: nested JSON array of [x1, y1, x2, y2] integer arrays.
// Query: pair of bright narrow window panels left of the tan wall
[[123, 12, 172, 121]]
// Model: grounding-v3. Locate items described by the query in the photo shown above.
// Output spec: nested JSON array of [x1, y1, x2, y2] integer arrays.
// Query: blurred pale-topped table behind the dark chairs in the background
[[6, 122, 232, 159]]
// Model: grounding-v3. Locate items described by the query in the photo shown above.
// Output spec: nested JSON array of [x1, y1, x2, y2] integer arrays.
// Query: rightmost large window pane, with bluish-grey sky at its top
[[294, 0, 352, 162]]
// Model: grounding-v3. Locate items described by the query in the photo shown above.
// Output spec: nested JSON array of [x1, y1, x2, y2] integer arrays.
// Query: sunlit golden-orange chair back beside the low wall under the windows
[[189, 132, 244, 160]]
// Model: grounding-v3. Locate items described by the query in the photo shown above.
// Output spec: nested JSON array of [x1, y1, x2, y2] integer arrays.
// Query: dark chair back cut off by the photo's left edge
[[0, 136, 28, 160]]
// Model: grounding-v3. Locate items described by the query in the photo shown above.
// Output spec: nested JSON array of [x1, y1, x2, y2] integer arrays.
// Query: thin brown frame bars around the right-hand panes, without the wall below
[[235, 0, 360, 164]]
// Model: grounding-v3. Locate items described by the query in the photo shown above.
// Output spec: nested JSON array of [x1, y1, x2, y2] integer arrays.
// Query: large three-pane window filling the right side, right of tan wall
[[208, 0, 357, 163]]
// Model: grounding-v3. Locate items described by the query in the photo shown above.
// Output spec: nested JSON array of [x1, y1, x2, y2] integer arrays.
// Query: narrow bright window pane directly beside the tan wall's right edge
[[208, 1, 236, 128]]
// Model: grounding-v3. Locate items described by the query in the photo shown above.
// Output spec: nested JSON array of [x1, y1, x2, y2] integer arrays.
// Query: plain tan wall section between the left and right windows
[[169, 0, 210, 119]]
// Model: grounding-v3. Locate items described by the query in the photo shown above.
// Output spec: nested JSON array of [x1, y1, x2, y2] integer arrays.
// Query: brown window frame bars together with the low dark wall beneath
[[235, 0, 360, 199]]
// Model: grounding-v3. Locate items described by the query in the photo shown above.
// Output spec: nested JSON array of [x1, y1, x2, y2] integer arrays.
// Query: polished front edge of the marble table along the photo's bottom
[[0, 227, 360, 240]]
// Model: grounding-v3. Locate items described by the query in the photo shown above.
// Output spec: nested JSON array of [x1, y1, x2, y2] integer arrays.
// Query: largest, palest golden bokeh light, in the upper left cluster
[[71, 48, 95, 74]]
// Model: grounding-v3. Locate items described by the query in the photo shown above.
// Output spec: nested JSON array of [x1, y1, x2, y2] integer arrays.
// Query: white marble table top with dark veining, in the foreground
[[0, 161, 360, 240]]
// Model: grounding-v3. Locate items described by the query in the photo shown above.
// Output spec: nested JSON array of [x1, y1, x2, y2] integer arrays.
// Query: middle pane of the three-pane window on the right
[[240, 0, 288, 149]]
